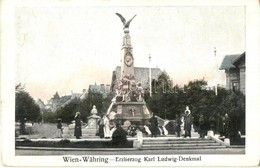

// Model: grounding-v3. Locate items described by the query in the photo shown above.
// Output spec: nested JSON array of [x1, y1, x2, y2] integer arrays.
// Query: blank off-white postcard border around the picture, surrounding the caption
[[1, 0, 260, 167]]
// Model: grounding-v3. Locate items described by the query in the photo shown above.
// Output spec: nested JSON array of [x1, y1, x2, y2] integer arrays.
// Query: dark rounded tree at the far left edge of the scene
[[15, 84, 41, 134]]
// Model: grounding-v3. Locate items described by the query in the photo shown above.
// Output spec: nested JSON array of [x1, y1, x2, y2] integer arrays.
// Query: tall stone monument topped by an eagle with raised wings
[[107, 13, 151, 127]]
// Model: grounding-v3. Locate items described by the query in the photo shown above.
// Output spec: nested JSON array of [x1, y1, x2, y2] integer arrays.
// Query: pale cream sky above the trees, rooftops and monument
[[15, 6, 246, 101]]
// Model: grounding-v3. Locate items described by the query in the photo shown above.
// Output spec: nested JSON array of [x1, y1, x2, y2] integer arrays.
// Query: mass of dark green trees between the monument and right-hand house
[[145, 71, 245, 138]]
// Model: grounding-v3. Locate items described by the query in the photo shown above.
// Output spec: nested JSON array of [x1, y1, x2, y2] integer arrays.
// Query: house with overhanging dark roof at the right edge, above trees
[[219, 52, 246, 95]]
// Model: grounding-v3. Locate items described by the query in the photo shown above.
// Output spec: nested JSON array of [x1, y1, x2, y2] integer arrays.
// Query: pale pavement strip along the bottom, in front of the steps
[[15, 148, 245, 156]]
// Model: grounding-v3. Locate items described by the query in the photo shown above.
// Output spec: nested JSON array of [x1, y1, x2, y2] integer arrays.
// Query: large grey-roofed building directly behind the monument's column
[[111, 66, 162, 93]]
